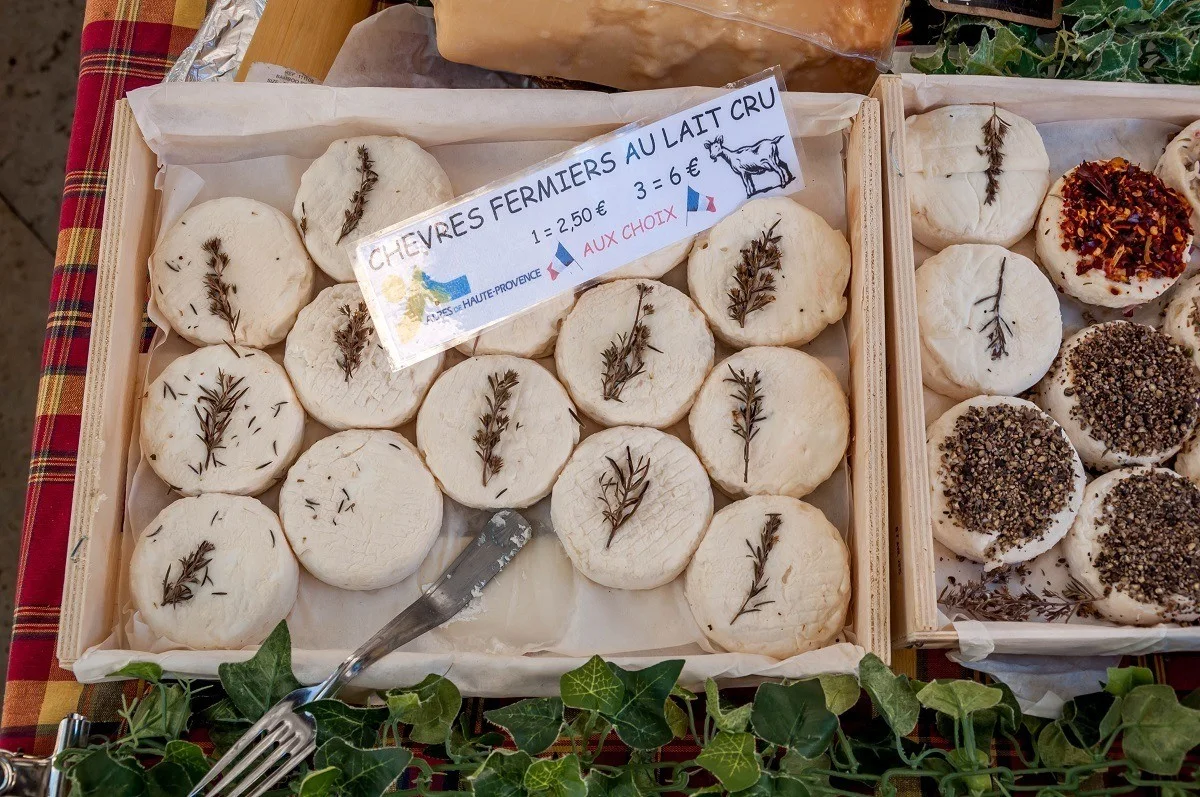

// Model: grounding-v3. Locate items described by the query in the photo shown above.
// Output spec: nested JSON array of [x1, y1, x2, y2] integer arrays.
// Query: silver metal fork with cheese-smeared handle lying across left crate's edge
[[188, 509, 533, 797]]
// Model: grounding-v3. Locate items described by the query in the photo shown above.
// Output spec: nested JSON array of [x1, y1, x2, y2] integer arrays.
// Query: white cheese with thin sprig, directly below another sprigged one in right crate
[[917, 244, 1062, 399]]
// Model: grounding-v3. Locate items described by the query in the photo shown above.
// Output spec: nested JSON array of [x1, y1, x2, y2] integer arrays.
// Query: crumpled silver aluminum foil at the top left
[[163, 0, 266, 83]]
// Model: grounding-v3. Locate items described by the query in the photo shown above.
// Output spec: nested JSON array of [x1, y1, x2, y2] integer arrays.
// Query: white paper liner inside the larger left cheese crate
[[73, 84, 863, 695]]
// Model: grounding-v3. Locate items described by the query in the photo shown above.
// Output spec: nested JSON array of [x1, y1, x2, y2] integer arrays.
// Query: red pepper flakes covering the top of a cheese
[[1060, 157, 1192, 283]]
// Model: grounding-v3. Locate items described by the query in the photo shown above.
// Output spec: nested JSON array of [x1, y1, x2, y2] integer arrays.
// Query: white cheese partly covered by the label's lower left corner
[[283, 283, 445, 430]]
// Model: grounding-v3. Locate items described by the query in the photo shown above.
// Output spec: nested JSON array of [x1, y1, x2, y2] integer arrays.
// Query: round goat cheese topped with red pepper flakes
[[1037, 157, 1192, 307]]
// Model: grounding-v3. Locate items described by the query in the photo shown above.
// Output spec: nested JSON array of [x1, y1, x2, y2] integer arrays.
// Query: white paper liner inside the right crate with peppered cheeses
[[904, 76, 1200, 657]]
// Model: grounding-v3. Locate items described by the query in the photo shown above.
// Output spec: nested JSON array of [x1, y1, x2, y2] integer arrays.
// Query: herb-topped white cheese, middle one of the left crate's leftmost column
[[140, 344, 305, 496]]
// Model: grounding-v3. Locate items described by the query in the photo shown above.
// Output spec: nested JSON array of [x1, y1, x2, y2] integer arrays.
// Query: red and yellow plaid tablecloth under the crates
[[0, 0, 1200, 755]]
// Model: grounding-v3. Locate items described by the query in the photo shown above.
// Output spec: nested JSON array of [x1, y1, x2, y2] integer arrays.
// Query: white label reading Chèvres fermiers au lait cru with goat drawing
[[354, 73, 804, 368]]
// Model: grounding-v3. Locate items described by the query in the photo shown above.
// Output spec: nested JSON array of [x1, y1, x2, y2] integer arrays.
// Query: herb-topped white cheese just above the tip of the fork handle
[[416, 354, 580, 509]]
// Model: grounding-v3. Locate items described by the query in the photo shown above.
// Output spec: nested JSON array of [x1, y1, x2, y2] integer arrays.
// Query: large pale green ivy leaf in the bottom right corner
[[1121, 684, 1200, 775]]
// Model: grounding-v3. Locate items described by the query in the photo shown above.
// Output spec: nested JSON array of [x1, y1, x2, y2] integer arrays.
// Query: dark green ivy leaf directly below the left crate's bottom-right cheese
[[750, 681, 838, 759]]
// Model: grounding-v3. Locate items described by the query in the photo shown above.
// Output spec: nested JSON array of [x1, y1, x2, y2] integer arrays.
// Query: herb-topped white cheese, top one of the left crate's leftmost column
[[150, 197, 316, 348]]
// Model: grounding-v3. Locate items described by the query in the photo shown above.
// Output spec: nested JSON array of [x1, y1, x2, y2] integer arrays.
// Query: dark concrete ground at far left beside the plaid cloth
[[0, 0, 84, 696]]
